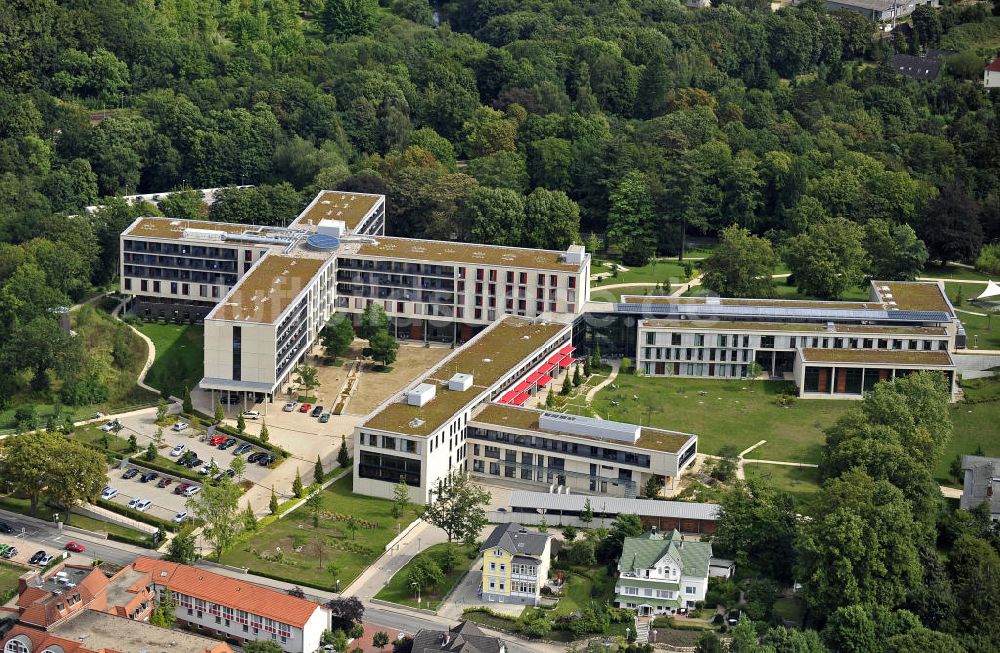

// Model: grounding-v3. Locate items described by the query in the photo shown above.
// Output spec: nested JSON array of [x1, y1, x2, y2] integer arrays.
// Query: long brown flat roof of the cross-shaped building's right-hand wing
[[356, 236, 583, 272]]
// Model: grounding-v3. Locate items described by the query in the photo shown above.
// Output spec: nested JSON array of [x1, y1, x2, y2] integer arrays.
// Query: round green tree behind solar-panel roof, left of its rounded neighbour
[[701, 225, 778, 297]]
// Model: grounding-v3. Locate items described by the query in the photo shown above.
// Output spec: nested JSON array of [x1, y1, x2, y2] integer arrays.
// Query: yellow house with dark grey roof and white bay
[[479, 524, 552, 605]]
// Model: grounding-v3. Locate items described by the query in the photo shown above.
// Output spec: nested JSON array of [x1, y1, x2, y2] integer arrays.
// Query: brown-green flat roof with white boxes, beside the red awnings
[[362, 317, 568, 436]]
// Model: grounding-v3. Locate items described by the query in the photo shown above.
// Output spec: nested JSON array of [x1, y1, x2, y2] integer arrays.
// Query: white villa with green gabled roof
[[615, 530, 712, 615]]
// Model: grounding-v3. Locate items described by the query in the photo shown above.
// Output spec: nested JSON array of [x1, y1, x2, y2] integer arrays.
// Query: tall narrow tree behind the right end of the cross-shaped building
[[606, 170, 656, 265]]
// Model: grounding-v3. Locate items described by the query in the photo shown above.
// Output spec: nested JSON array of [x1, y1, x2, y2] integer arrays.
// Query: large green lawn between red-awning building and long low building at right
[[577, 375, 853, 463]]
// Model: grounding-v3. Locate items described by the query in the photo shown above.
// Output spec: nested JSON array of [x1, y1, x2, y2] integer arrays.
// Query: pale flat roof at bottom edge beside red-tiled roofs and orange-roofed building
[[48, 610, 229, 653]]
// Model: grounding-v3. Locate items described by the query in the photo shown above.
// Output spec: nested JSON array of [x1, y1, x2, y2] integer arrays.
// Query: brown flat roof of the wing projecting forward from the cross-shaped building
[[206, 253, 328, 324]]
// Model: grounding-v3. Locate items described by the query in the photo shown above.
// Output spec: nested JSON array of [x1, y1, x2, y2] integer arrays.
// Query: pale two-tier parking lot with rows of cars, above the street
[[108, 428, 271, 519]]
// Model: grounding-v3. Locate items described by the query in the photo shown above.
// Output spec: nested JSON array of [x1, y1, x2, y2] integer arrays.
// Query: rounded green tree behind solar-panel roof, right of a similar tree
[[784, 218, 869, 299]]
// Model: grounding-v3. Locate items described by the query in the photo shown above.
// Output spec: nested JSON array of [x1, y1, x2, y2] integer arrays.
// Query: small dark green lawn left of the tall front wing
[[136, 322, 205, 397]]
